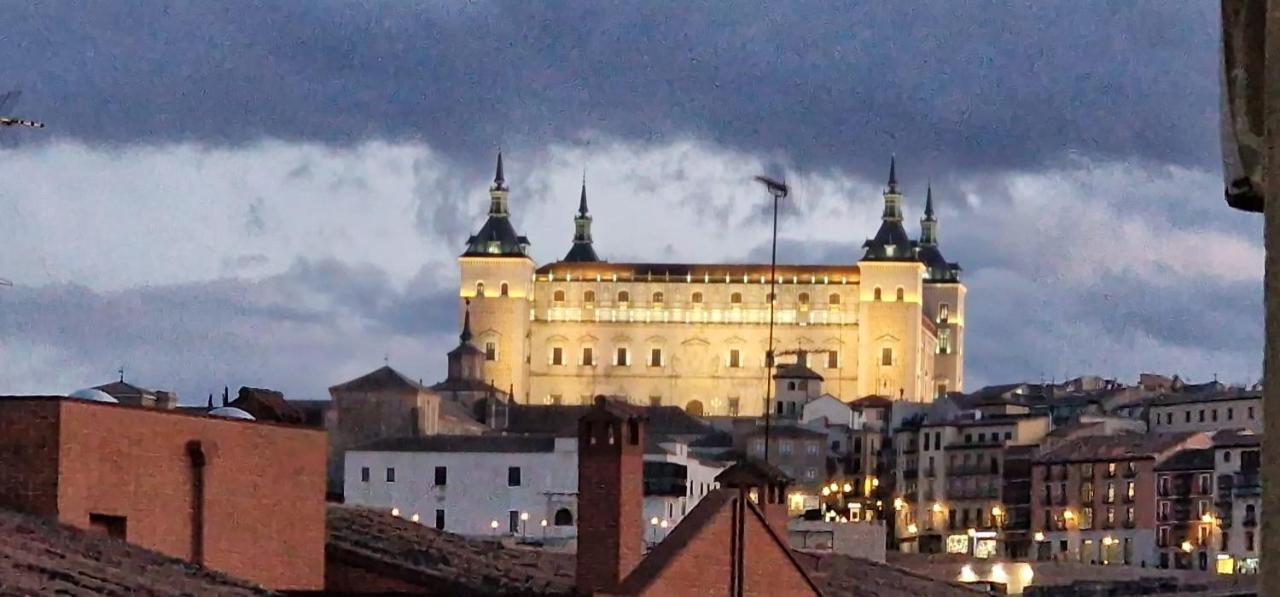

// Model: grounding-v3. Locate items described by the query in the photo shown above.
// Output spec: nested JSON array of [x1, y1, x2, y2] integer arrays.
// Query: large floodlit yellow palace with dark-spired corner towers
[[458, 155, 965, 415]]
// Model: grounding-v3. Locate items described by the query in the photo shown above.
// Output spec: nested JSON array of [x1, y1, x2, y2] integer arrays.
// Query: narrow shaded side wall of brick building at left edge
[[0, 398, 58, 516]]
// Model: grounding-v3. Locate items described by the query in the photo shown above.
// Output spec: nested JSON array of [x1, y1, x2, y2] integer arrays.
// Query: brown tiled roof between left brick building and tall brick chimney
[[325, 505, 575, 596]]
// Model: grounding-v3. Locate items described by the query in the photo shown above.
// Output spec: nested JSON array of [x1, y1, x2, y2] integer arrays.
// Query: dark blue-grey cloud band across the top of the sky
[[0, 0, 1217, 179]]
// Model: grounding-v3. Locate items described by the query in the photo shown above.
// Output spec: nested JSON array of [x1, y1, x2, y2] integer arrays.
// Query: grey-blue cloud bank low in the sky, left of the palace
[[0, 260, 456, 402]]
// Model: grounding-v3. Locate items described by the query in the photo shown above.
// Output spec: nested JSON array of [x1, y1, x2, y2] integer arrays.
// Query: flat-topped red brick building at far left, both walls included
[[0, 397, 325, 589]]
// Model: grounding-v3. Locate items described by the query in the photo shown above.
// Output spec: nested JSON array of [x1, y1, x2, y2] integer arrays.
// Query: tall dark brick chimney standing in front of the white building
[[577, 396, 646, 594]]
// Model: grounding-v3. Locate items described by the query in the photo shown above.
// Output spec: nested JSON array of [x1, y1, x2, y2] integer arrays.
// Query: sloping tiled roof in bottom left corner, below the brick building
[[0, 510, 269, 596]]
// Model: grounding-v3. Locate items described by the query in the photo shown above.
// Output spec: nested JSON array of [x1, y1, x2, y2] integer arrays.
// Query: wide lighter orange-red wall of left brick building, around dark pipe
[[48, 401, 326, 589]]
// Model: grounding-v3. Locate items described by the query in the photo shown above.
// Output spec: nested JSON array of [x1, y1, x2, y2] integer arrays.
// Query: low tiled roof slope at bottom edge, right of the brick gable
[[796, 551, 987, 597]]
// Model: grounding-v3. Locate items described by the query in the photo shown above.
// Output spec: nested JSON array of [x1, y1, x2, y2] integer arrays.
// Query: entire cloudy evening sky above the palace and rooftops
[[0, 0, 1262, 402]]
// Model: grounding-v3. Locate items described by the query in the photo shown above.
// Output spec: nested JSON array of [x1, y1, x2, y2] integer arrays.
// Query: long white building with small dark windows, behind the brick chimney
[[343, 436, 724, 542]]
